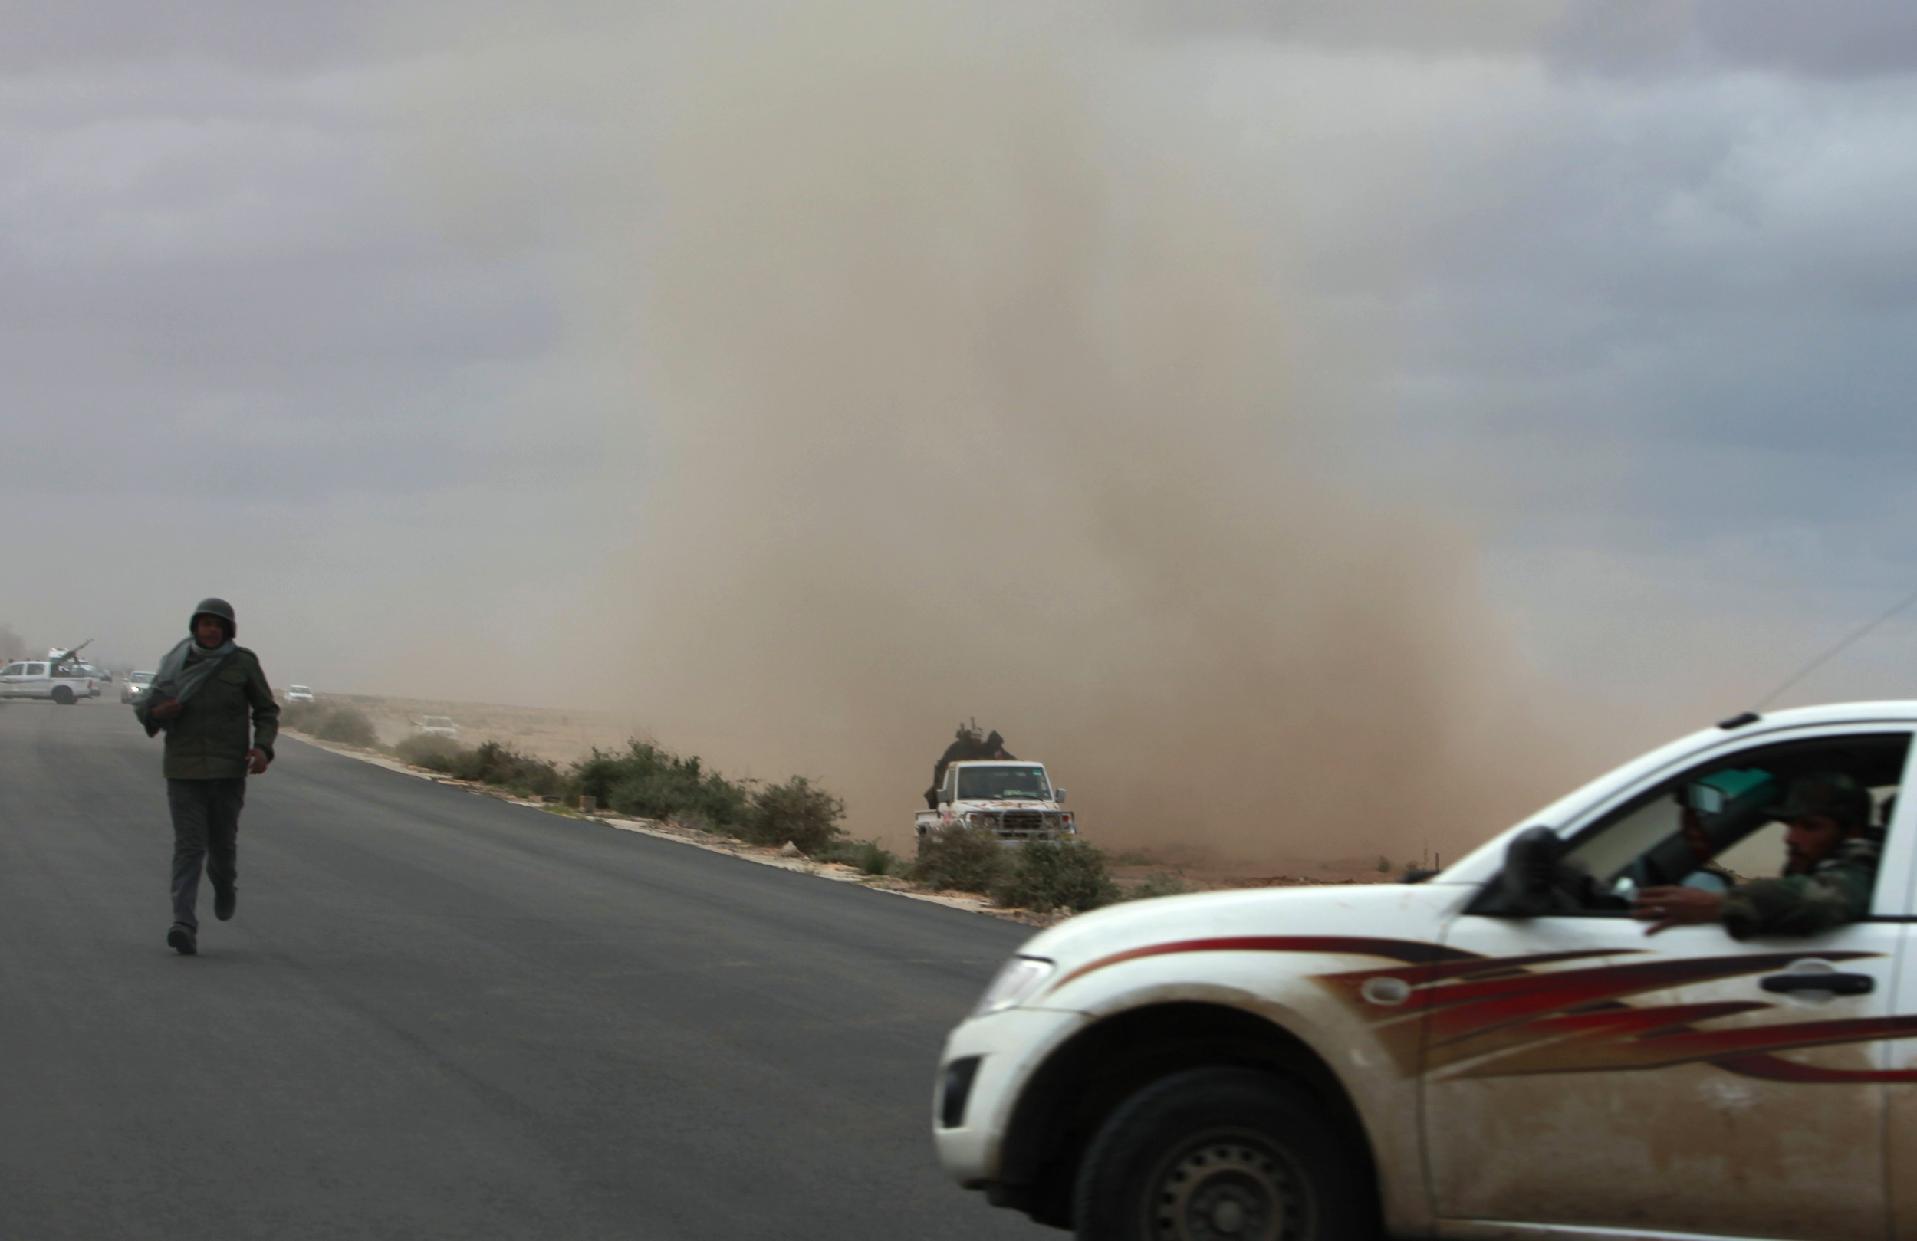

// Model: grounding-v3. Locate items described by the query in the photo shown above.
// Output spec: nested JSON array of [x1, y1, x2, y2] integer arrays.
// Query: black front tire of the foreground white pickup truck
[[1072, 1068, 1378, 1241]]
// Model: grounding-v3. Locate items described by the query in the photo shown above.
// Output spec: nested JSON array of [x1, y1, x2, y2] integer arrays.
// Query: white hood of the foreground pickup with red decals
[[1018, 884, 1474, 972]]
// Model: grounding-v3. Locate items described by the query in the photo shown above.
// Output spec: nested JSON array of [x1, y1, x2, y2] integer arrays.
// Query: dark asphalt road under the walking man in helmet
[[0, 687, 1062, 1241]]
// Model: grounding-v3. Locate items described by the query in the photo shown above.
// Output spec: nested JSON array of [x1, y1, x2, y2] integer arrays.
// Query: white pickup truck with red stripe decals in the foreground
[[934, 702, 1917, 1241]]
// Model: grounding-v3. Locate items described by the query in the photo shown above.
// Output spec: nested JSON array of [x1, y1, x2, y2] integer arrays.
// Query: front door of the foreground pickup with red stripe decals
[[1420, 725, 1917, 1241]]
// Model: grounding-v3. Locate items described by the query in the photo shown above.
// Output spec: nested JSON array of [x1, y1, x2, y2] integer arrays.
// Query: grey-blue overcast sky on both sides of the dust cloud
[[11, 0, 1917, 774]]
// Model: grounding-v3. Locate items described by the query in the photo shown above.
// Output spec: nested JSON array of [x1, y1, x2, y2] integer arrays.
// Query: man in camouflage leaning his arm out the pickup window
[[1631, 771, 1881, 940]]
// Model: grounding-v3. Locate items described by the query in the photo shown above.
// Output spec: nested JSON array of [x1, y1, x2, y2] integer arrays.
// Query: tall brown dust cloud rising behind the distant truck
[[419, 0, 1648, 865]]
